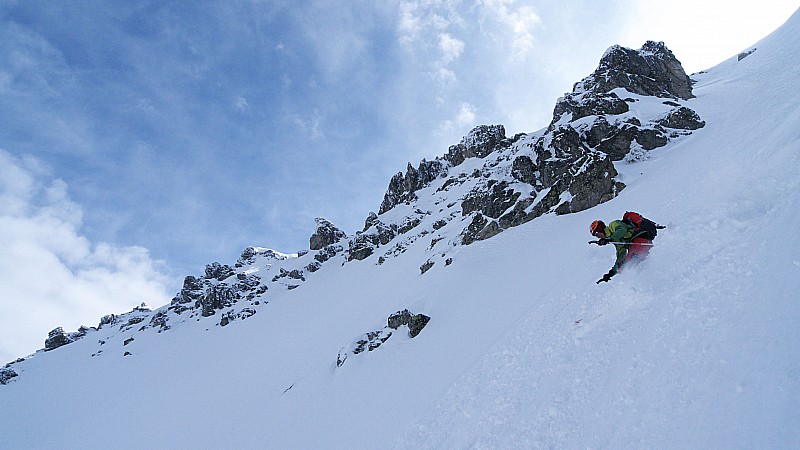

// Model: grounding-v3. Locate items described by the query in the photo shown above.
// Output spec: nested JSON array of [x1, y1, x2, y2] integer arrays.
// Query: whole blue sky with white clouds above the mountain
[[0, 0, 800, 360]]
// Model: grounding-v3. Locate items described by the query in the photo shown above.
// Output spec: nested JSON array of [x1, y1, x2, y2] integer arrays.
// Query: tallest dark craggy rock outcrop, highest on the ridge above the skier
[[451, 41, 705, 244]]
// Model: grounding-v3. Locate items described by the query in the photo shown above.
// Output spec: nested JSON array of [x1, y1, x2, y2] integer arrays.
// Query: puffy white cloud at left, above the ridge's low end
[[0, 150, 169, 361]]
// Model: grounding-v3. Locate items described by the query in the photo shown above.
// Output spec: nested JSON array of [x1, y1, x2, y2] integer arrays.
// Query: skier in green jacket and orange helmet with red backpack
[[590, 213, 663, 284]]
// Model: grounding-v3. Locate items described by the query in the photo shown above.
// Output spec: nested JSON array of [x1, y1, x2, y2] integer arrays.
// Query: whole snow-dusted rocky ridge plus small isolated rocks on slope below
[[0, 41, 705, 384]]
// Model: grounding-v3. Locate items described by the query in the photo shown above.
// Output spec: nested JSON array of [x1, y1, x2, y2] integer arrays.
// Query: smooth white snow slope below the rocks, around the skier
[[0, 7, 800, 448]]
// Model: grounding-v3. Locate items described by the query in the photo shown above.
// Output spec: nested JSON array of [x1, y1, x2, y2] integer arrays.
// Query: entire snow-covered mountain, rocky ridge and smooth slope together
[[0, 7, 800, 448]]
